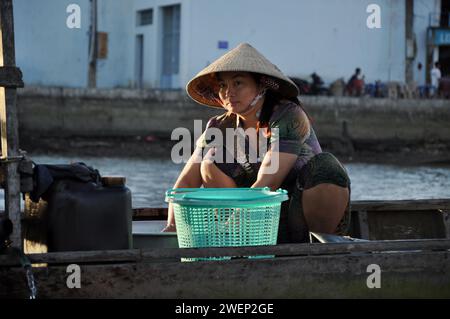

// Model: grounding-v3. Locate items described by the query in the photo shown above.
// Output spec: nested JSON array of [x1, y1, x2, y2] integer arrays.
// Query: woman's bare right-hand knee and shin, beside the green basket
[[302, 184, 350, 234]]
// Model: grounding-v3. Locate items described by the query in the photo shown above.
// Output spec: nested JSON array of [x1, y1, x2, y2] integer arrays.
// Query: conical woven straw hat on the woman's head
[[186, 43, 299, 107]]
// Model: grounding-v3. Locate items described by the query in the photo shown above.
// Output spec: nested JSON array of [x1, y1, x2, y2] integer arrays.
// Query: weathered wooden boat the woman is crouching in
[[0, 199, 450, 298]]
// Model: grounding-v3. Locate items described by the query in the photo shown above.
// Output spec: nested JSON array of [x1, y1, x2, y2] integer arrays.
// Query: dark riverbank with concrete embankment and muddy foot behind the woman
[[17, 87, 450, 164]]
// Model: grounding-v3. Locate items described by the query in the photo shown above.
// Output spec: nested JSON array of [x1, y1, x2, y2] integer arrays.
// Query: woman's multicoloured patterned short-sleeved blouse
[[196, 100, 322, 190]]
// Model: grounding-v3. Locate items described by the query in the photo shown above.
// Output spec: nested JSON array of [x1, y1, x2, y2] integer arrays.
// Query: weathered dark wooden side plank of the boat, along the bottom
[[0, 251, 450, 298]]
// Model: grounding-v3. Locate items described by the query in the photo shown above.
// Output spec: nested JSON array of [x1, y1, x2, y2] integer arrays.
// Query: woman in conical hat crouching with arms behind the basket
[[164, 44, 350, 243]]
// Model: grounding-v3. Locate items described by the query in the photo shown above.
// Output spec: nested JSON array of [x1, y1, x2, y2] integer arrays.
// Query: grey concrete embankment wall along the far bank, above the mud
[[17, 88, 450, 143]]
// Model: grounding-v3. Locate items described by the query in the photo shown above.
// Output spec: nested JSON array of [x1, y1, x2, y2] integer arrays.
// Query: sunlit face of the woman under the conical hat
[[218, 72, 260, 114]]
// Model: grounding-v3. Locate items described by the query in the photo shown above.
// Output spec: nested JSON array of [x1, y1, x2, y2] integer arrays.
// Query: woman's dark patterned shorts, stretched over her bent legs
[[216, 153, 351, 243]]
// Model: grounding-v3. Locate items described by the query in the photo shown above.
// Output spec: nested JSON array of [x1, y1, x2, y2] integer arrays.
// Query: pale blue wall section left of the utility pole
[[13, 0, 89, 87]]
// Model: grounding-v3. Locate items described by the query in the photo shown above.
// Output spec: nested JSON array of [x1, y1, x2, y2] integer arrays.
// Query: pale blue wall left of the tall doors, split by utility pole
[[14, 0, 134, 88]]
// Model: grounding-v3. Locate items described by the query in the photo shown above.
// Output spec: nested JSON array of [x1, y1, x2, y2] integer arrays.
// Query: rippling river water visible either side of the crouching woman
[[0, 156, 450, 208]]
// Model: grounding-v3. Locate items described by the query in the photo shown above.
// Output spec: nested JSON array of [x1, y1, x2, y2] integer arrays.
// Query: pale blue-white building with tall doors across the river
[[14, 0, 441, 89]]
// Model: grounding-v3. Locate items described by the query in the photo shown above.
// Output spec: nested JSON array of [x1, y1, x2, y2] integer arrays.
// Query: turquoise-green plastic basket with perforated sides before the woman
[[166, 187, 288, 260]]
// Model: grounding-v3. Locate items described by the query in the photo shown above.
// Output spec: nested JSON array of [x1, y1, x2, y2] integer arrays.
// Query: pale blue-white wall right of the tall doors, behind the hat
[[187, 0, 405, 82]]
